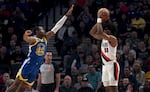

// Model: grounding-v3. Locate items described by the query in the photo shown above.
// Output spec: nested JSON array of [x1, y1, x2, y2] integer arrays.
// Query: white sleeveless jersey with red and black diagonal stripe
[[101, 39, 117, 64]]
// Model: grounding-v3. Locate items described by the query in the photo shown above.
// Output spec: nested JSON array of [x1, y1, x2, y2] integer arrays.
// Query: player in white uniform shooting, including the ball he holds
[[90, 8, 119, 92]]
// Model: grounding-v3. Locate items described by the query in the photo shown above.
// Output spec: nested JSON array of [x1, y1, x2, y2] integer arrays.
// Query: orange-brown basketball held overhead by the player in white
[[98, 8, 110, 21]]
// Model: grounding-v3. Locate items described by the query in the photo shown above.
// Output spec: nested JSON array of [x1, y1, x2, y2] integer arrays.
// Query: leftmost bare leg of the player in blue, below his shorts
[[5, 78, 21, 92]]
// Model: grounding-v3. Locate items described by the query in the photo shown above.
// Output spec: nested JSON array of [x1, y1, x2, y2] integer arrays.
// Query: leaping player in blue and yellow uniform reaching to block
[[6, 5, 74, 92]]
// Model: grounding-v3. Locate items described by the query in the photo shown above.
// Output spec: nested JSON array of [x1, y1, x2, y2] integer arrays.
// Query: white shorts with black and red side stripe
[[102, 62, 120, 87]]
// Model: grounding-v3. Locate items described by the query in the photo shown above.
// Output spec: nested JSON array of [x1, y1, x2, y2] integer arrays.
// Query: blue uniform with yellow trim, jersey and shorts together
[[16, 37, 47, 85]]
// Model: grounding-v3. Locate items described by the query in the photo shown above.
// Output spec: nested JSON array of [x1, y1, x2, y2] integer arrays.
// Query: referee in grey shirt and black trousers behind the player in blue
[[36, 52, 60, 92]]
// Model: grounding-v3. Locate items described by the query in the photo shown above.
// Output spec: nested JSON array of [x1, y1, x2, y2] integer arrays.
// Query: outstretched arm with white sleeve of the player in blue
[[46, 5, 74, 40]]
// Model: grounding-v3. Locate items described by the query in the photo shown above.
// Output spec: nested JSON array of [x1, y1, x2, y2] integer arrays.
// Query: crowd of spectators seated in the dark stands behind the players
[[0, 0, 150, 92]]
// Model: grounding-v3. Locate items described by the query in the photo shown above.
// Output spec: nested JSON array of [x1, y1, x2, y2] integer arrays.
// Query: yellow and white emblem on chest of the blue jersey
[[36, 43, 45, 56]]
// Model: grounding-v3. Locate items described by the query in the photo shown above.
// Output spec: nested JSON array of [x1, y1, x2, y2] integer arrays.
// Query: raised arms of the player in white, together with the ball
[[90, 8, 117, 47]]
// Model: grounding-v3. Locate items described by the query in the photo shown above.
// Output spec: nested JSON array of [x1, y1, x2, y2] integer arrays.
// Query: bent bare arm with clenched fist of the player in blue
[[23, 30, 36, 45]]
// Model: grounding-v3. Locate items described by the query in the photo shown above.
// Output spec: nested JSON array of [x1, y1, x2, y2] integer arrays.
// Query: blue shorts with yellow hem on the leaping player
[[16, 60, 40, 86]]
